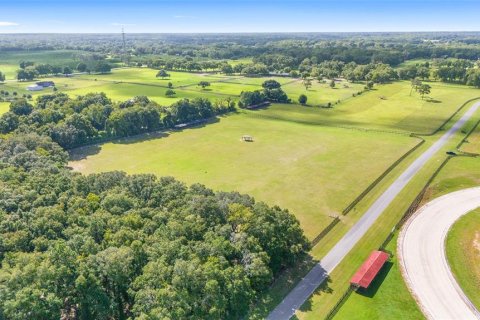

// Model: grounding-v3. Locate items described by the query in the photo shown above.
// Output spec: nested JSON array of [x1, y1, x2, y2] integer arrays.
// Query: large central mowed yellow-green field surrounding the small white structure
[[70, 105, 416, 238]]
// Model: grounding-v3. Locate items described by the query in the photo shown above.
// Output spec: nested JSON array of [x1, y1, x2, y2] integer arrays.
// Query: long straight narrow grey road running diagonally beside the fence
[[267, 102, 480, 320]]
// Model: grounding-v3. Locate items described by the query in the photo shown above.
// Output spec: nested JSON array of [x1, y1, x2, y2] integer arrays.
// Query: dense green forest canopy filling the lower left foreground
[[0, 131, 308, 320]]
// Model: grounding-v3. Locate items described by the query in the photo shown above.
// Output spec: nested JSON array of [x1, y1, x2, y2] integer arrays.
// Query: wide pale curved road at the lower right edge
[[398, 187, 480, 320]]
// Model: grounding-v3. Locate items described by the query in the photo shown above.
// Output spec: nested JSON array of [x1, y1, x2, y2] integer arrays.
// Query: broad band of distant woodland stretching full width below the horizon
[[0, 32, 480, 86]]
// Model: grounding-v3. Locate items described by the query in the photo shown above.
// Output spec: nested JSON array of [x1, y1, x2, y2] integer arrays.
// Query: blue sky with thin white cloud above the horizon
[[0, 0, 480, 33]]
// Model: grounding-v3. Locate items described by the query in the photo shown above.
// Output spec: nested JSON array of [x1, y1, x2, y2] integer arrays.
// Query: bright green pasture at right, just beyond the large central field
[[258, 81, 480, 133]]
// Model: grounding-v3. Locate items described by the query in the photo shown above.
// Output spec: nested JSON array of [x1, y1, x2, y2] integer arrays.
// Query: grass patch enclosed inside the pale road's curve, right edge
[[446, 209, 480, 309]]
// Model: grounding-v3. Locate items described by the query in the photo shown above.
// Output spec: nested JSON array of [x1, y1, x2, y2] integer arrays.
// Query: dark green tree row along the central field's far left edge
[[0, 93, 235, 149]]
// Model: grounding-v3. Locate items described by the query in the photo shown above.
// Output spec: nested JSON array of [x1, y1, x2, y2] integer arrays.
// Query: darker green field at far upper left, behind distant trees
[[0, 50, 86, 79]]
